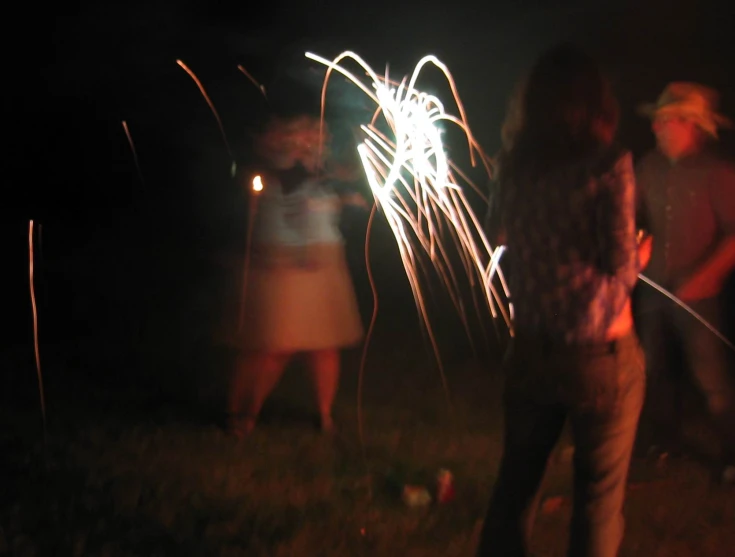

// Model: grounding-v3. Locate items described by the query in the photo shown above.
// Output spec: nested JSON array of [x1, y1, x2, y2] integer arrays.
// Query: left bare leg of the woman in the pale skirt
[[228, 353, 291, 436]]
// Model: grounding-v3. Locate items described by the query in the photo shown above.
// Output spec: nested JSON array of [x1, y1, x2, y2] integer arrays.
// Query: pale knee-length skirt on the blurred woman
[[224, 244, 363, 352]]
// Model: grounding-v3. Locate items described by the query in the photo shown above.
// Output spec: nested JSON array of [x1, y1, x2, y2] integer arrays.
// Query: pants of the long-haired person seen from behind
[[477, 334, 645, 557]]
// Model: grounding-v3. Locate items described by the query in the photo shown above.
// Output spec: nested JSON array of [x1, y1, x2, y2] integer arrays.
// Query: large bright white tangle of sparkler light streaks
[[306, 51, 513, 334]]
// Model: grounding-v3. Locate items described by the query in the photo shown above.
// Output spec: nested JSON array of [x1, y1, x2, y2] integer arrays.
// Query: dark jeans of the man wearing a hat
[[636, 292, 735, 463]]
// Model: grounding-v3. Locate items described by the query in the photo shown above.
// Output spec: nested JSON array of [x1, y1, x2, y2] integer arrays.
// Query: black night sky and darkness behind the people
[[0, 0, 735, 554]]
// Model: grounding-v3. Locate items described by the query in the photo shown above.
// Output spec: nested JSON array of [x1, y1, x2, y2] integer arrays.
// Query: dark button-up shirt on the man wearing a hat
[[636, 151, 735, 288]]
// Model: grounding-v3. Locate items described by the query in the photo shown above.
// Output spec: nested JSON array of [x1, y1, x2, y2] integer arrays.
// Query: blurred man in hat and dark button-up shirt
[[636, 83, 735, 481]]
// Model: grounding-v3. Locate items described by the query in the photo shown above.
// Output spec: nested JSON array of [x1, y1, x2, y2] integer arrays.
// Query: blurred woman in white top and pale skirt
[[228, 117, 367, 437]]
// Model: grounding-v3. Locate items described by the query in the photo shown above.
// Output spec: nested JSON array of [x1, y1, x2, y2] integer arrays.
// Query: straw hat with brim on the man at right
[[638, 82, 732, 137]]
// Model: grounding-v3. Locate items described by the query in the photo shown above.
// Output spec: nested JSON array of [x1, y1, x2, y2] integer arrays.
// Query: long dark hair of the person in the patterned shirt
[[498, 44, 619, 189]]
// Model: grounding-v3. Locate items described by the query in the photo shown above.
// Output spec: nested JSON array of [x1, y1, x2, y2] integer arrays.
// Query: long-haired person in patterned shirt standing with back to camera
[[477, 45, 650, 557]]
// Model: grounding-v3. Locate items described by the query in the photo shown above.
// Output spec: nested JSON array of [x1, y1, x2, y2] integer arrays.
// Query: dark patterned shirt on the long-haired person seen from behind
[[487, 152, 639, 345]]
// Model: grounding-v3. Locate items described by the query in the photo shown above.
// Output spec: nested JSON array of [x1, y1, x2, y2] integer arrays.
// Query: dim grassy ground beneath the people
[[0, 330, 735, 557]]
